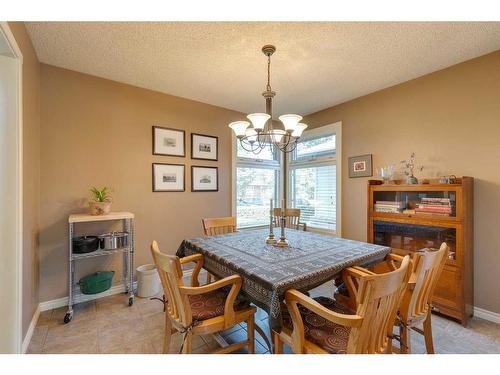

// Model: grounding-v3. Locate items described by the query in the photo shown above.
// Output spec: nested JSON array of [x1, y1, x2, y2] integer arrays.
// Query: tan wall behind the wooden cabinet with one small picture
[[305, 51, 500, 313]]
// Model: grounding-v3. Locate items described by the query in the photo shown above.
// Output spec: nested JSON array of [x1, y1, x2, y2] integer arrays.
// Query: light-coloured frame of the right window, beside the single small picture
[[286, 121, 342, 237]]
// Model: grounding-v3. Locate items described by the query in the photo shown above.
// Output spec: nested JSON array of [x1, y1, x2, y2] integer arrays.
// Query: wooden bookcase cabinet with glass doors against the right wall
[[368, 177, 474, 326]]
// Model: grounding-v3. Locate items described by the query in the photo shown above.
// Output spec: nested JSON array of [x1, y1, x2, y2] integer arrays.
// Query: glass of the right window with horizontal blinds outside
[[288, 126, 338, 233]]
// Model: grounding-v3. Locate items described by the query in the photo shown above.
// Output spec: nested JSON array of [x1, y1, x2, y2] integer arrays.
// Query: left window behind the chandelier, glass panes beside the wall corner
[[234, 140, 280, 228]]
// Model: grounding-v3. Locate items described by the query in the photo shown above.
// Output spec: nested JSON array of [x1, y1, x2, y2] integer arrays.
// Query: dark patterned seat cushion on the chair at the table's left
[[188, 289, 250, 320]]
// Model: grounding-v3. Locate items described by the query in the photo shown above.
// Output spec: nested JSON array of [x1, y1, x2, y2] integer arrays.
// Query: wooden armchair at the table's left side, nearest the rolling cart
[[151, 241, 256, 353]]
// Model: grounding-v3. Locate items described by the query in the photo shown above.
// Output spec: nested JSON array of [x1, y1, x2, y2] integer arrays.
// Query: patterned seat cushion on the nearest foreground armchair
[[283, 297, 355, 354]]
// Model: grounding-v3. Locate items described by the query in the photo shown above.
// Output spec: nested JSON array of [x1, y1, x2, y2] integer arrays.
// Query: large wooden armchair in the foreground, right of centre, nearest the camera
[[273, 256, 410, 354]]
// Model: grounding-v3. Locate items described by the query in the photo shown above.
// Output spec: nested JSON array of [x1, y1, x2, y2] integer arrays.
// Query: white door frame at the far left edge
[[0, 21, 23, 353]]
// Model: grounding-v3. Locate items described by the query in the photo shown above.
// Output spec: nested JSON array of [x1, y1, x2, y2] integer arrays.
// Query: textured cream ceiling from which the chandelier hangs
[[27, 22, 500, 115]]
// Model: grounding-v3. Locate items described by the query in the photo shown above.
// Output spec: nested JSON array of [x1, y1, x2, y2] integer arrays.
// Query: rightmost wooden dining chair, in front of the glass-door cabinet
[[389, 242, 450, 354]]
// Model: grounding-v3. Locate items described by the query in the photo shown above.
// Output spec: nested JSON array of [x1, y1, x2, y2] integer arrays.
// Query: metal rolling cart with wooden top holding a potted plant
[[64, 212, 135, 323]]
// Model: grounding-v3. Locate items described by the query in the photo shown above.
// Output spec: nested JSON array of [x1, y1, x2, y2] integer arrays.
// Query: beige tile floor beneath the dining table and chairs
[[28, 284, 500, 354]]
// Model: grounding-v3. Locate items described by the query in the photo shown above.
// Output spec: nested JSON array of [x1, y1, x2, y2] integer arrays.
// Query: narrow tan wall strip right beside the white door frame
[[9, 22, 40, 337]]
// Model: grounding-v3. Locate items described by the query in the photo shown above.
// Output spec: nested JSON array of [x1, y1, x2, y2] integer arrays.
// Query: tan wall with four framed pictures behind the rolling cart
[[40, 64, 242, 301]]
